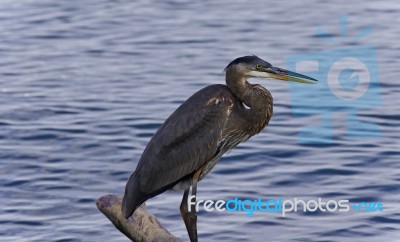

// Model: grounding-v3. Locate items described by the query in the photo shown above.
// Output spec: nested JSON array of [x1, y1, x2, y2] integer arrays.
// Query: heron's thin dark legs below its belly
[[181, 171, 200, 242]]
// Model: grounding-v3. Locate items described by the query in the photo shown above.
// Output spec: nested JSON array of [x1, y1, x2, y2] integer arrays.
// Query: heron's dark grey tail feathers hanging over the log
[[122, 173, 143, 218]]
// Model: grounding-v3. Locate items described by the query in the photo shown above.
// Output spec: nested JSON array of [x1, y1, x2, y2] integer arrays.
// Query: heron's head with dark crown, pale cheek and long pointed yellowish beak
[[225, 55, 318, 84]]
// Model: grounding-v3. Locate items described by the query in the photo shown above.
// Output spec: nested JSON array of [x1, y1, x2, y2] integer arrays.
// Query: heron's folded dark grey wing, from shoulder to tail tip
[[123, 85, 235, 217]]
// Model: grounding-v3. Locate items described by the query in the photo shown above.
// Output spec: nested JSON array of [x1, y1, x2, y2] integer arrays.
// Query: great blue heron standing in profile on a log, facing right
[[122, 56, 317, 242]]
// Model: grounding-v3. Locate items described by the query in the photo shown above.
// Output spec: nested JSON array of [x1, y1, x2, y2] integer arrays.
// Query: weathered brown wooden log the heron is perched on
[[96, 195, 183, 242]]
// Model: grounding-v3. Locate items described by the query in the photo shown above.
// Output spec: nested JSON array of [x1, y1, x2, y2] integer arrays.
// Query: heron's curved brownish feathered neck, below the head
[[226, 69, 273, 128]]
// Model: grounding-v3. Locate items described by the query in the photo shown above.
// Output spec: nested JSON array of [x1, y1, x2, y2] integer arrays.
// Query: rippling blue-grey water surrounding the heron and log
[[0, 0, 400, 242]]
